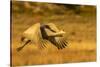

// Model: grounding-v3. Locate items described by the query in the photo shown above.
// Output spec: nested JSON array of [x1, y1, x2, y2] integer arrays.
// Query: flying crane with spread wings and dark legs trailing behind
[[17, 23, 68, 51]]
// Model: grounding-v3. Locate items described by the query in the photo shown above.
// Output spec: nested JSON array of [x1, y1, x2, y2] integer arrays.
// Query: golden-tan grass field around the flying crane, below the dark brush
[[11, 1, 96, 66]]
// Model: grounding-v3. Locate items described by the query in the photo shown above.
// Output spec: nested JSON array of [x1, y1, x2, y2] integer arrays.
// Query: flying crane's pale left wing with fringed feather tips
[[22, 23, 47, 48]]
